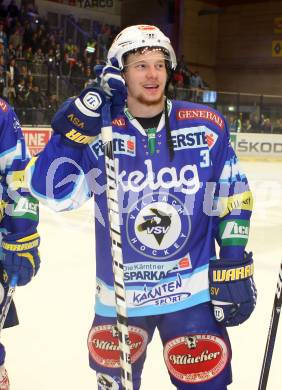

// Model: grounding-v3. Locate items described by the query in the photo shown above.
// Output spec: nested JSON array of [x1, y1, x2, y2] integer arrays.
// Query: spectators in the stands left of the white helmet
[[0, 0, 120, 124]]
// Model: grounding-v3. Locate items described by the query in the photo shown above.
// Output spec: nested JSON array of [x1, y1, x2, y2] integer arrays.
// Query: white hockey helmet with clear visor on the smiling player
[[108, 24, 177, 70]]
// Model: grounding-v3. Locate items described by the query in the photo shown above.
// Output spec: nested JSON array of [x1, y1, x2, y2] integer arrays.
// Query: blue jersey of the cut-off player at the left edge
[[0, 99, 38, 242]]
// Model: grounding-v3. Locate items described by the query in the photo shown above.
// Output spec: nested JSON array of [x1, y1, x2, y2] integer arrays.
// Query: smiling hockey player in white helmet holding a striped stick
[[26, 25, 256, 390]]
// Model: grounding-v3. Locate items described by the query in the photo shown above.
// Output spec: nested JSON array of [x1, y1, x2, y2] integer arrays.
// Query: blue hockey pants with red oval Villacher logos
[[88, 302, 232, 390]]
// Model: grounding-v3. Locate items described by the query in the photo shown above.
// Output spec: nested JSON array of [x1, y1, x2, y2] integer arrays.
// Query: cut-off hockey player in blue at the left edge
[[0, 99, 40, 390]]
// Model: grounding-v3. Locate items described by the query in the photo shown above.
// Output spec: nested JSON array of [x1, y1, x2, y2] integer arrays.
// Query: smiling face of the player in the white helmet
[[124, 49, 167, 109]]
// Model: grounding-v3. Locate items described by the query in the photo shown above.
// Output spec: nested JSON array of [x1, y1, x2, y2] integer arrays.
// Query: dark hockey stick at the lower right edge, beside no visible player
[[258, 262, 282, 390]]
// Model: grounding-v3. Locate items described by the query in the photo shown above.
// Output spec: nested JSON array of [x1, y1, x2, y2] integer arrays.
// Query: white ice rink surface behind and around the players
[[1, 161, 282, 390]]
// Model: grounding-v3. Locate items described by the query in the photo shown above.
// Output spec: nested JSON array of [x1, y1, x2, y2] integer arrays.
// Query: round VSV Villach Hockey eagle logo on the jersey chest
[[126, 193, 191, 259]]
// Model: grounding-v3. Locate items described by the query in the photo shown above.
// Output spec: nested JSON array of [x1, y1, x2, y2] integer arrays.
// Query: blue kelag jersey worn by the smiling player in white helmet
[[26, 101, 252, 316]]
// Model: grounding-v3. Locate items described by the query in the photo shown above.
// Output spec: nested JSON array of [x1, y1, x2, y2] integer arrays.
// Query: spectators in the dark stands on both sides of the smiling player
[[0, 0, 282, 133]]
